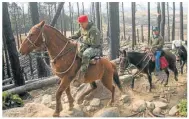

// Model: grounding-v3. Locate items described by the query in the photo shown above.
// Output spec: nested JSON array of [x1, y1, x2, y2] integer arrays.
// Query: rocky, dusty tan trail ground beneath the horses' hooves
[[3, 64, 187, 117]]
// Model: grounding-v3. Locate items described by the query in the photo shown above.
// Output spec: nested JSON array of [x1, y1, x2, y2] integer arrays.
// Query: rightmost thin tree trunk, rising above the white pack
[[180, 2, 184, 40]]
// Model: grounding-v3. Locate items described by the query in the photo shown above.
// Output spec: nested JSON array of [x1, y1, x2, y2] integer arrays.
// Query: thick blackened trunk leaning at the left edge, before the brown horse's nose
[[3, 2, 25, 86]]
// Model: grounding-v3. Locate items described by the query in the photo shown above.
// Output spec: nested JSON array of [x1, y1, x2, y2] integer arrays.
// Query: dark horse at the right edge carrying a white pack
[[176, 45, 187, 74]]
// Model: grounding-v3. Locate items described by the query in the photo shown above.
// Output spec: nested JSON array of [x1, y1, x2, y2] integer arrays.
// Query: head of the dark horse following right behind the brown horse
[[119, 50, 129, 73]]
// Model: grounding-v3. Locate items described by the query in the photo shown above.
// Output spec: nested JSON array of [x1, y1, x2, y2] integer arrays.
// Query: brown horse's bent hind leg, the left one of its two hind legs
[[78, 82, 97, 104]]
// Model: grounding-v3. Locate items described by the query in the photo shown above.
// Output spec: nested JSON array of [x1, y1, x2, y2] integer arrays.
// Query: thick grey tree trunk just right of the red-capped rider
[[109, 2, 120, 60]]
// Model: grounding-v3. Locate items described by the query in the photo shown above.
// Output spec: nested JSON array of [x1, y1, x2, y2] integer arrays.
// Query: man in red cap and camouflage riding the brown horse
[[69, 15, 101, 79]]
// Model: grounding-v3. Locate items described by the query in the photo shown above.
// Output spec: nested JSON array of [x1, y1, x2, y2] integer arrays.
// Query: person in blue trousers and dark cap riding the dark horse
[[152, 27, 164, 72]]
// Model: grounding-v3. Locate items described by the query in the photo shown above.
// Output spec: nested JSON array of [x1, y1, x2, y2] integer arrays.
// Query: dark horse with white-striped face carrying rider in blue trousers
[[120, 50, 178, 92]]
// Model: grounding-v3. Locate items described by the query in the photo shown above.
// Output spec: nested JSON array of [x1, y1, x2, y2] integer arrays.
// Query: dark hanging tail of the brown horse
[[111, 62, 123, 92]]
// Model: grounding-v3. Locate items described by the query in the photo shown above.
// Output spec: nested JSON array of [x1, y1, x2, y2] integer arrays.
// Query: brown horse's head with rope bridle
[[19, 21, 45, 55]]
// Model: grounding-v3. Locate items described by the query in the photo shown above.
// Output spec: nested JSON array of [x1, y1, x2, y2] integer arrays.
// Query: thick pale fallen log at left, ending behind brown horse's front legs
[[6, 76, 59, 94]]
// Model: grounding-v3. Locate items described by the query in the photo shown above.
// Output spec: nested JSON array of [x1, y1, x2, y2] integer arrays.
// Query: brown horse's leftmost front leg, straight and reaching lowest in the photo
[[53, 78, 70, 117]]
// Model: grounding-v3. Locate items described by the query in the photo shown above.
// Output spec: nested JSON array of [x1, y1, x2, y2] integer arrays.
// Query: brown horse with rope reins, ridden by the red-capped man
[[20, 21, 122, 116]]
